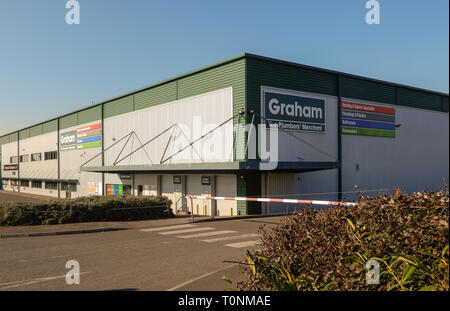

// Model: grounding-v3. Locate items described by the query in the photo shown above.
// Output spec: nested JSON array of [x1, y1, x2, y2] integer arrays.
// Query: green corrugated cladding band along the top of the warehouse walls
[[0, 54, 449, 144]]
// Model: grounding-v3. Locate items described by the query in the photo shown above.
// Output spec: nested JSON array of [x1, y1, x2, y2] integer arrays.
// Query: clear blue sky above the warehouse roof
[[0, 0, 449, 135]]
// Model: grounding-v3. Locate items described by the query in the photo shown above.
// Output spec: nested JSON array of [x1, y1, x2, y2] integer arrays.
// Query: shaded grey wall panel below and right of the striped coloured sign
[[342, 100, 449, 199]]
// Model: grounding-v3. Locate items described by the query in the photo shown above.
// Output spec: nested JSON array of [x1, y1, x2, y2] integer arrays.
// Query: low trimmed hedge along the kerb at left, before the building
[[0, 196, 173, 226]]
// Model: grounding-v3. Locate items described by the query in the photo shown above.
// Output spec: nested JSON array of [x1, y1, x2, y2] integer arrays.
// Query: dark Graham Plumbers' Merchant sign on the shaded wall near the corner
[[261, 91, 325, 132]]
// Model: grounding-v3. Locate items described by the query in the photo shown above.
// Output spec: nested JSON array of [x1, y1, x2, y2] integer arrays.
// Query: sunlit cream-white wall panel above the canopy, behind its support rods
[[104, 88, 233, 165]]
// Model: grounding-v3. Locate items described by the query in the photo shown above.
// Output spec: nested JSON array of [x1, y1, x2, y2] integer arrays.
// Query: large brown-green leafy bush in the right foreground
[[238, 187, 449, 290]]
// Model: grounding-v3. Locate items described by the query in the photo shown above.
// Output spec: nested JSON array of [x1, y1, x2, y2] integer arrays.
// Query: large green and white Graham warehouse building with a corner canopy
[[0, 54, 449, 215]]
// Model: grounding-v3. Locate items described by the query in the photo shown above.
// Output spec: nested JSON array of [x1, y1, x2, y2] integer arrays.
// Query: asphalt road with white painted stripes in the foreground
[[0, 217, 281, 290]]
